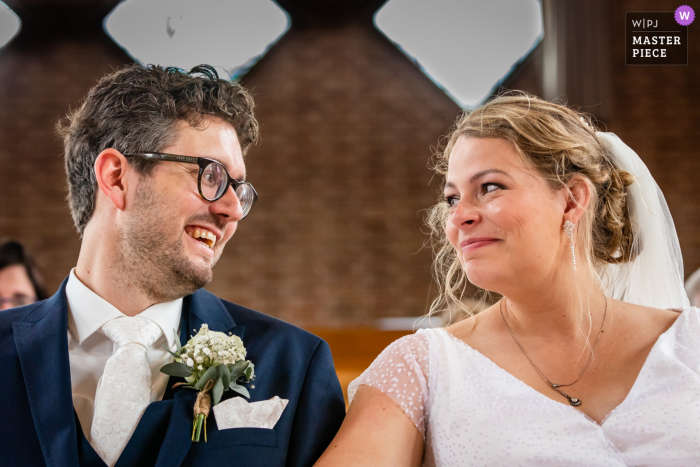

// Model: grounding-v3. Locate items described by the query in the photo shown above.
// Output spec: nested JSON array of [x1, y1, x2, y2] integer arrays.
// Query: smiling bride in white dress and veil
[[317, 94, 700, 467]]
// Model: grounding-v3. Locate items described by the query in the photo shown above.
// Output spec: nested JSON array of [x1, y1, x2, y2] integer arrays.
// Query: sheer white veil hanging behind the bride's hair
[[596, 132, 689, 308]]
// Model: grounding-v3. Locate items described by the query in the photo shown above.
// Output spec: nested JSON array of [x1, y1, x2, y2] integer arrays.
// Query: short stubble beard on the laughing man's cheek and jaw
[[116, 175, 221, 303]]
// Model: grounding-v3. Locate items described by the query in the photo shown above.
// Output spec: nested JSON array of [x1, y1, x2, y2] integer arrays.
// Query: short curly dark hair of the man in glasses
[[56, 64, 259, 235]]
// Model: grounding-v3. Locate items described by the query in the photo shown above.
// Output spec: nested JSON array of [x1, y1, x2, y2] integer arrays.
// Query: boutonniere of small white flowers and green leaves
[[160, 324, 255, 443]]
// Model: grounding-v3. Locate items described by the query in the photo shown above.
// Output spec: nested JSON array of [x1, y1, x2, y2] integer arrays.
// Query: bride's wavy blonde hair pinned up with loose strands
[[426, 92, 634, 315]]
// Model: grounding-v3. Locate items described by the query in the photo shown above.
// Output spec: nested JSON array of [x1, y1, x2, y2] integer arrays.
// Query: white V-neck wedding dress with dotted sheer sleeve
[[348, 308, 700, 467]]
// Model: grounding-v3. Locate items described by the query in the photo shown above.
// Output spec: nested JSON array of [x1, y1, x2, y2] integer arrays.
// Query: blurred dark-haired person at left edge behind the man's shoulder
[[0, 240, 49, 310]]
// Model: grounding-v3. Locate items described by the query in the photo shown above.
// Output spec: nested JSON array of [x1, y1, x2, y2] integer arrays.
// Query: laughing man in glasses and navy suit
[[0, 65, 345, 467]]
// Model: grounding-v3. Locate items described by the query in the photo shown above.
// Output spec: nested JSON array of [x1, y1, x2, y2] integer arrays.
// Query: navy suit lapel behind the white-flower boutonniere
[[156, 289, 245, 467]]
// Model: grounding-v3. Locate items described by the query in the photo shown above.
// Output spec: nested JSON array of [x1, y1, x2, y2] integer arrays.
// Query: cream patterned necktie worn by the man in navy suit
[[90, 316, 161, 467]]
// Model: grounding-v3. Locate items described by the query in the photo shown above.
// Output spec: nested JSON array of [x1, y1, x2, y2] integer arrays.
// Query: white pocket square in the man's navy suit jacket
[[214, 396, 289, 430]]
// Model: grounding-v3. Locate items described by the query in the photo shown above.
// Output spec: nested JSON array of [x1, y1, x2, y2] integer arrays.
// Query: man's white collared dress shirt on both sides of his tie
[[66, 269, 182, 441]]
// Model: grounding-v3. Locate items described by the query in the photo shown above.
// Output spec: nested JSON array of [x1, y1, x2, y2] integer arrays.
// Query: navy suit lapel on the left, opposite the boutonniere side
[[12, 281, 78, 467]]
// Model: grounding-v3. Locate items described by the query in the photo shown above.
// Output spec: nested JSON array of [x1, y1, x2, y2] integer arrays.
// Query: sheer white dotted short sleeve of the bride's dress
[[348, 333, 428, 439]]
